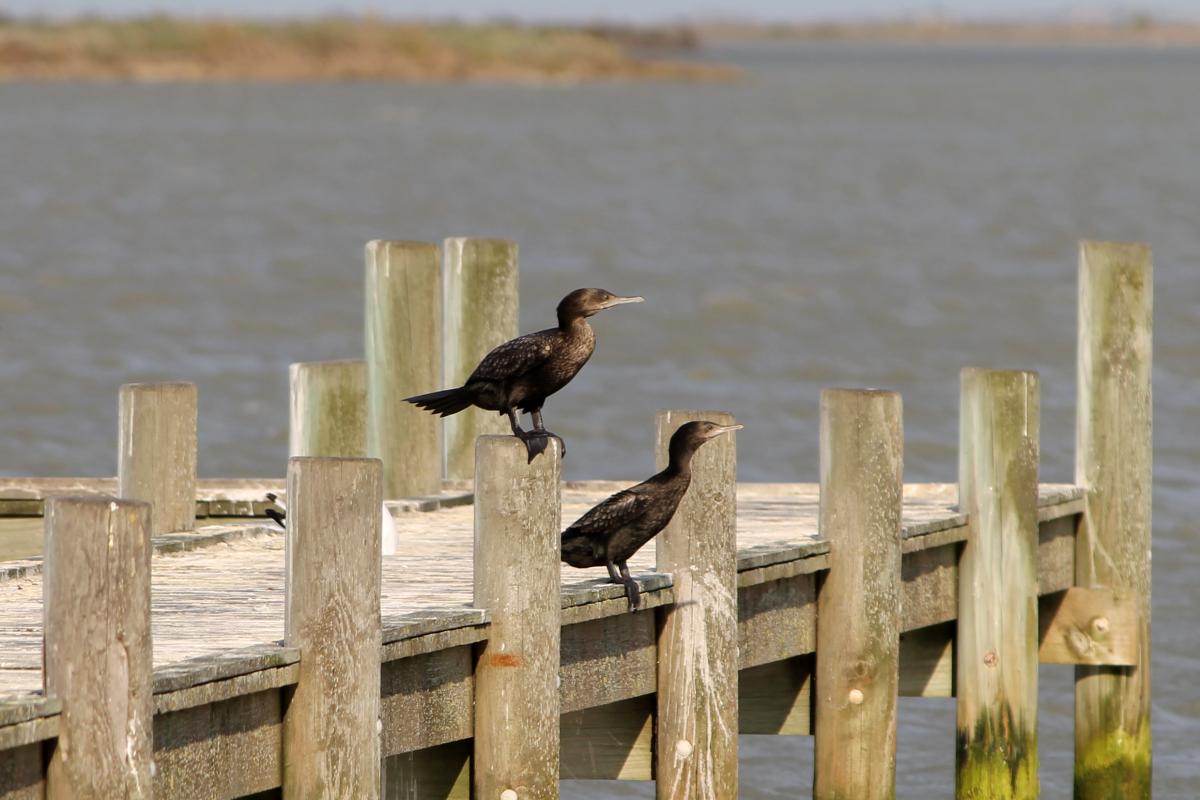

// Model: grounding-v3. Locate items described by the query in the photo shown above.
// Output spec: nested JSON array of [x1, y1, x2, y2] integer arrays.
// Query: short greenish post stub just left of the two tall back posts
[[288, 359, 367, 458]]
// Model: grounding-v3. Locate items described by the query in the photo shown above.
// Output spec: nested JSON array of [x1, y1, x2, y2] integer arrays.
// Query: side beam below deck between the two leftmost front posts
[[154, 690, 283, 800]]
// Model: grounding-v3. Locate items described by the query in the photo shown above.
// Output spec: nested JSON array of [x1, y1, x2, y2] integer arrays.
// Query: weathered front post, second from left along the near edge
[[283, 458, 383, 800]]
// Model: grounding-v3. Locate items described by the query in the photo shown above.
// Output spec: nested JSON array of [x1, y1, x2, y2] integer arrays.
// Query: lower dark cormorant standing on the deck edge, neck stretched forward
[[563, 422, 742, 610]]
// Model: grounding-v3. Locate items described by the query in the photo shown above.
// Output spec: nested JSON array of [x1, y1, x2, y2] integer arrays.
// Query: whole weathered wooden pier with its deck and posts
[[0, 240, 1152, 800]]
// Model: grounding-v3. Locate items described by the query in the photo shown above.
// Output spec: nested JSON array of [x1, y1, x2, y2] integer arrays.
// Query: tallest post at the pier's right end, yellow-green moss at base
[[1075, 241, 1153, 800]]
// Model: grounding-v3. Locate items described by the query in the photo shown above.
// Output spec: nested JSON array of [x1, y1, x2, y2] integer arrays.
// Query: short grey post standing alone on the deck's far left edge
[[116, 384, 197, 535]]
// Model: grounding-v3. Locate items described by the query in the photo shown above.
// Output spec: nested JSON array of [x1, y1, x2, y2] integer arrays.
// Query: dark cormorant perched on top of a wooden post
[[406, 289, 642, 461]]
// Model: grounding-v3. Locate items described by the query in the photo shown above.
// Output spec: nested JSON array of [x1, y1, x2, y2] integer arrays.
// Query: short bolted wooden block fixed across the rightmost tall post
[[1038, 587, 1138, 667]]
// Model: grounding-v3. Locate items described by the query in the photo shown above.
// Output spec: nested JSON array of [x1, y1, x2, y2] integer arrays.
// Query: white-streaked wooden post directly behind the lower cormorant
[[655, 410, 738, 800]]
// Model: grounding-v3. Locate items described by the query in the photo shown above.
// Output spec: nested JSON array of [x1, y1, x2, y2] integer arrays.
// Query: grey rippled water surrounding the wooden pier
[[0, 46, 1200, 800]]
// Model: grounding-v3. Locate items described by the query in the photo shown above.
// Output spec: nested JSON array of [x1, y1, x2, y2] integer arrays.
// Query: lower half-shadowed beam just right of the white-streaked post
[[738, 655, 814, 736]]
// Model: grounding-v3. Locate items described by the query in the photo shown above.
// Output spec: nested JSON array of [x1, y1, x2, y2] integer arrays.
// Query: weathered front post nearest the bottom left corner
[[44, 497, 154, 800]]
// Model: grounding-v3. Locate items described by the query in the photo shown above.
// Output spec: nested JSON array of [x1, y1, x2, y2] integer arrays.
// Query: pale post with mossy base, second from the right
[[955, 368, 1039, 800]]
